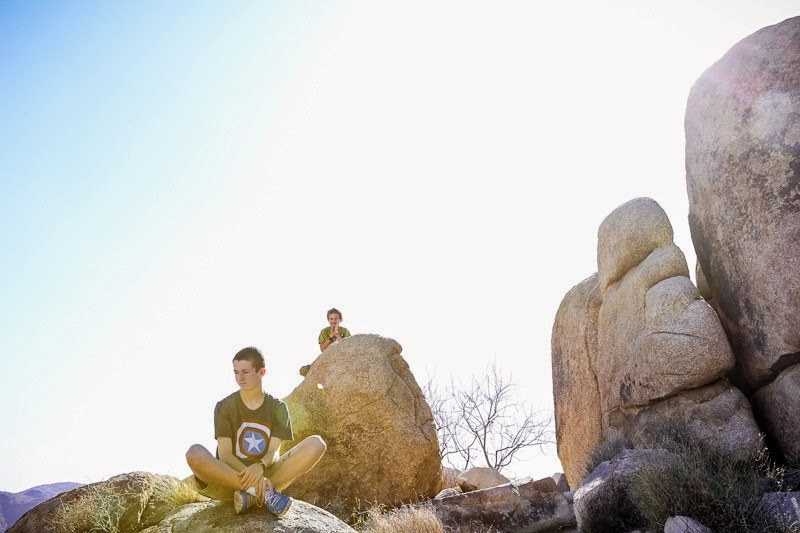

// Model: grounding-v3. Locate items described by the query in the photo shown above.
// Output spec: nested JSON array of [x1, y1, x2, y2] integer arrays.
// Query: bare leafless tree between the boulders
[[423, 364, 552, 471]]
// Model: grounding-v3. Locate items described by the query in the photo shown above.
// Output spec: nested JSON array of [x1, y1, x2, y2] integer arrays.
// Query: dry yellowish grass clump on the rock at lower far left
[[49, 485, 125, 533]]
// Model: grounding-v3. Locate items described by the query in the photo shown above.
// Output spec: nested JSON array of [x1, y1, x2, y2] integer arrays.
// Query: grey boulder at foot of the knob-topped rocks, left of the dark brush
[[573, 450, 681, 533]]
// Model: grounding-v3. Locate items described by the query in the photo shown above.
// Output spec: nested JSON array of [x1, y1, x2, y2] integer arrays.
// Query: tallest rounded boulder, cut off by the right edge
[[685, 17, 800, 394]]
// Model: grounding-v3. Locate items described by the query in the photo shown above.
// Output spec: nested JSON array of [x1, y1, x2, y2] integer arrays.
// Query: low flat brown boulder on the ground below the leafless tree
[[431, 478, 575, 533]]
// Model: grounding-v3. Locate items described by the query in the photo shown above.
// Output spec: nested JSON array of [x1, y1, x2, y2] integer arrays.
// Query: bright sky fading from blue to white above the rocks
[[0, 0, 797, 492]]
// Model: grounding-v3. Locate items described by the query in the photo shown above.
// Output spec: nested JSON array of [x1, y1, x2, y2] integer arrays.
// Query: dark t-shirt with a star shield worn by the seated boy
[[214, 391, 294, 465]]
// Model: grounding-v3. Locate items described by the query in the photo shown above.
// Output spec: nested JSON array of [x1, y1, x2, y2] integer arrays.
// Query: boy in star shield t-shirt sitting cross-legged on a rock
[[186, 347, 326, 518]]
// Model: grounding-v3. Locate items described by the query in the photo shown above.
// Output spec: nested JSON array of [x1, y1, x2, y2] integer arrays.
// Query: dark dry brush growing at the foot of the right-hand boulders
[[587, 423, 800, 533]]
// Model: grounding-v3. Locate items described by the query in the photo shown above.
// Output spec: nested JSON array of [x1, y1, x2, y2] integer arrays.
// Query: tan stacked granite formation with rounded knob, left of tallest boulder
[[551, 198, 761, 487]]
